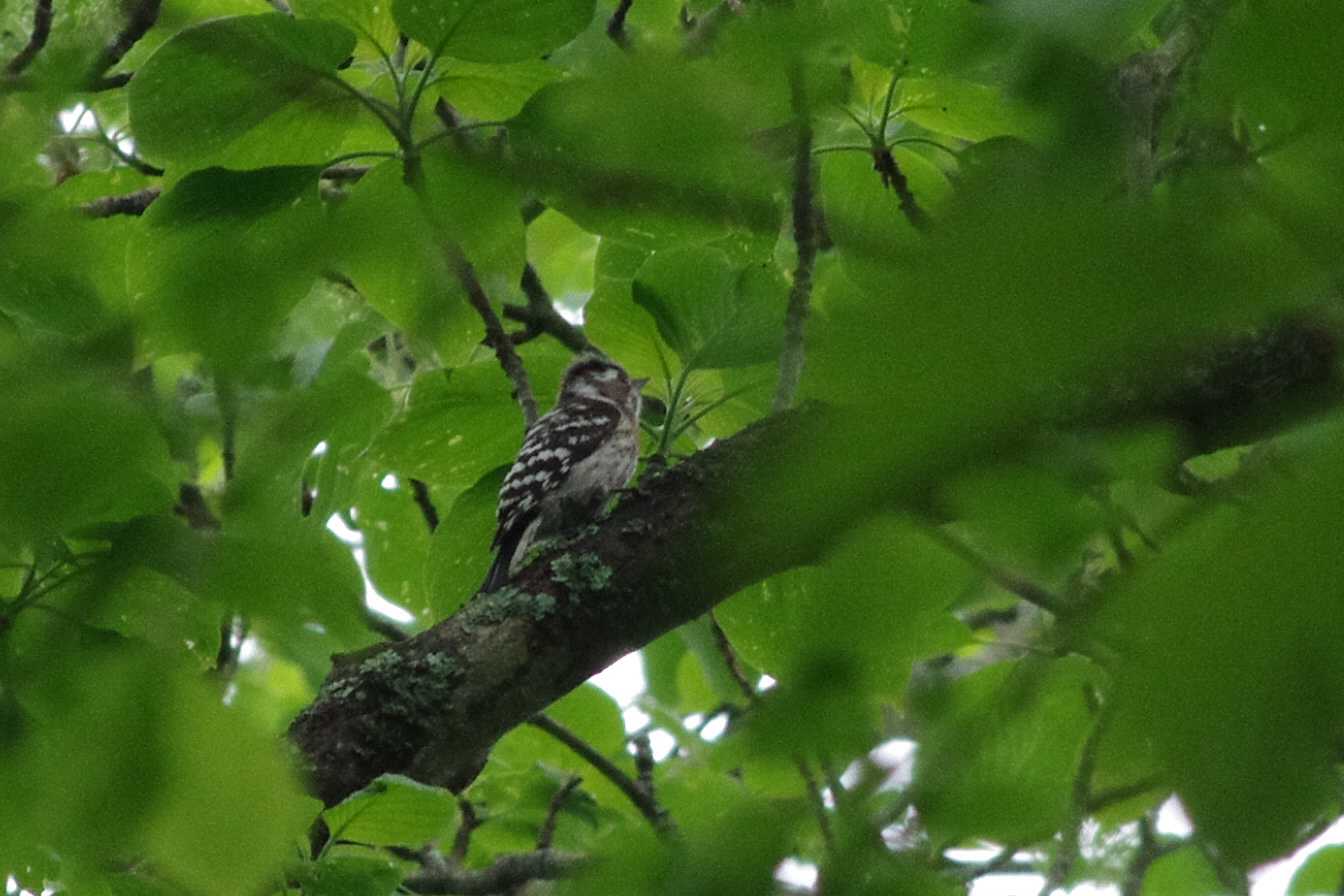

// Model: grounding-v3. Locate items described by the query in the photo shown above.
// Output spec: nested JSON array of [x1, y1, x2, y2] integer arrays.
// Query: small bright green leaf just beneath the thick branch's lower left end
[[323, 775, 458, 848]]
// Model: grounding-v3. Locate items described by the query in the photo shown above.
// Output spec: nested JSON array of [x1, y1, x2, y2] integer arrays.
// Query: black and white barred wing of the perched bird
[[491, 400, 621, 548]]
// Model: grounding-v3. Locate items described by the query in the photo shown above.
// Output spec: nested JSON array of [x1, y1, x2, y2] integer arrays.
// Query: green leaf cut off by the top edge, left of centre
[[392, 0, 594, 62]]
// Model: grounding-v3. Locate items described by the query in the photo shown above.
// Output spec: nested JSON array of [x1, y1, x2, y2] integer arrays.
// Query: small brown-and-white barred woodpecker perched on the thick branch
[[481, 355, 648, 591]]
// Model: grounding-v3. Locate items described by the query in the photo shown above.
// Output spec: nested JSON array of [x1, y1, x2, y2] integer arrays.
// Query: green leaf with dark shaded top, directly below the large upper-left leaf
[[128, 168, 324, 371]]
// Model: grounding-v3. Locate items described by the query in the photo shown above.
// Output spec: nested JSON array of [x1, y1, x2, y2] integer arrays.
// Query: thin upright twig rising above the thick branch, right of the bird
[[771, 66, 817, 414]]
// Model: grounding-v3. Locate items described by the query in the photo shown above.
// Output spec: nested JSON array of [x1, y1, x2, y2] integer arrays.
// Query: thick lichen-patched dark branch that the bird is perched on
[[290, 315, 1340, 802]]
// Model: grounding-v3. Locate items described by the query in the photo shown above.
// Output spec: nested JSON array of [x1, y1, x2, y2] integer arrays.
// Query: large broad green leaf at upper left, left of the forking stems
[[129, 13, 359, 168]]
